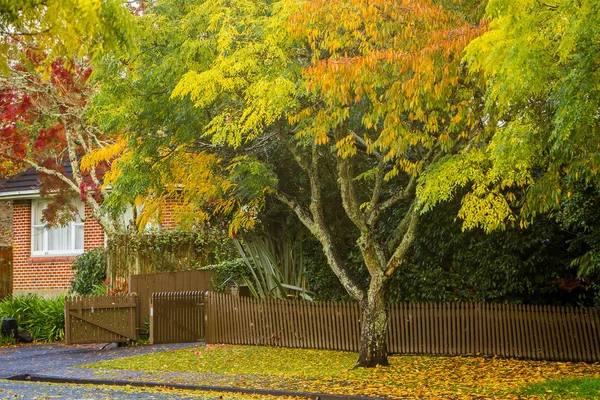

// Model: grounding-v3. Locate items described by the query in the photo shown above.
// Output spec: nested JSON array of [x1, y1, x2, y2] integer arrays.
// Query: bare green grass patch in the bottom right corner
[[520, 377, 600, 399]]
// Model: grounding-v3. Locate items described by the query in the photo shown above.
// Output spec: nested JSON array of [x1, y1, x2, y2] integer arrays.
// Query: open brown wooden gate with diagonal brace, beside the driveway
[[65, 294, 138, 344]]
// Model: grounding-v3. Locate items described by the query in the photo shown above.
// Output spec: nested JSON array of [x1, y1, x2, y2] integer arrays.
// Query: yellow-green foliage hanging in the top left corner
[[0, 0, 132, 72]]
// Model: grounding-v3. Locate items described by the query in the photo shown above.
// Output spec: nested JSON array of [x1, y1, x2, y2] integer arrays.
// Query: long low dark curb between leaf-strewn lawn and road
[[7, 374, 384, 400]]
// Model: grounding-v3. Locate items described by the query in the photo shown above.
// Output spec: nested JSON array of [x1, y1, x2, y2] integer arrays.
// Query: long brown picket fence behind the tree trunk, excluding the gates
[[205, 293, 600, 362]]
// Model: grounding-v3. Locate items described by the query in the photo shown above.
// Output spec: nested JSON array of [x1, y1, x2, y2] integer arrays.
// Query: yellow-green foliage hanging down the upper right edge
[[465, 0, 600, 228]]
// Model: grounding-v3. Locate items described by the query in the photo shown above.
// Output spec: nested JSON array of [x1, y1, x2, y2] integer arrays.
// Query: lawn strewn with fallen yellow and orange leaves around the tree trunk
[[86, 345, 600, 399]]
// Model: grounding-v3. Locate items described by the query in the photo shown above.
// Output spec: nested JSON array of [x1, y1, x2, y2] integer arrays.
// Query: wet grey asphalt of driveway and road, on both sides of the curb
[[0, 343, 206, 399]]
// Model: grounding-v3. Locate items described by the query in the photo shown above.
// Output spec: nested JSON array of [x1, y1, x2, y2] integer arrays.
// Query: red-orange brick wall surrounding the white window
[[13, 200, 104, 292]]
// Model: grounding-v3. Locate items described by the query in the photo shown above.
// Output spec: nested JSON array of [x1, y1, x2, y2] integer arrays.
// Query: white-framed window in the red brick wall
[[31, 200, 84, 256]]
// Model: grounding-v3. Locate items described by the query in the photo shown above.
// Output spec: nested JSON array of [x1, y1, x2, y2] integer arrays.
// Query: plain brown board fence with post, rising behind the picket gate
[[129, 270, 215, 327]]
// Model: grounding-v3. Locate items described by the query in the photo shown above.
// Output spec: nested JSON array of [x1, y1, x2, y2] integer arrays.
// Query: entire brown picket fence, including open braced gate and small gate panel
[[78, 291, 600, 362]]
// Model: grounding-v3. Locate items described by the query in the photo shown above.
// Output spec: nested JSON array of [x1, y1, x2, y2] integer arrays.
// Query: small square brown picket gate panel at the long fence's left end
[[150, 292, 204, 344]]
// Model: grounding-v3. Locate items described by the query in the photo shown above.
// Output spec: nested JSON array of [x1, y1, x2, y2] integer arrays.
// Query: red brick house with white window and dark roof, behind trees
[[0, 168, 105, 296]]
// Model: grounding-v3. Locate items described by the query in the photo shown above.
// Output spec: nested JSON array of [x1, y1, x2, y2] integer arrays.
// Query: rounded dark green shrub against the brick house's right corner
[[71, 248, 106, 295]]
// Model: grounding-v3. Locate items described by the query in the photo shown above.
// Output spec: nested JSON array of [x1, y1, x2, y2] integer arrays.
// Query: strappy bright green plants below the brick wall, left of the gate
[[0, 294, 65, 342]]
